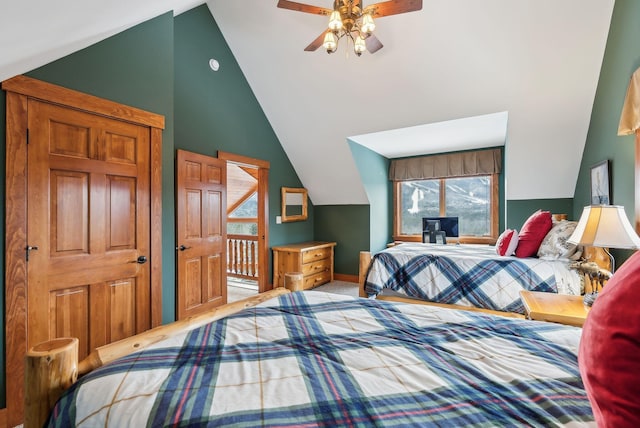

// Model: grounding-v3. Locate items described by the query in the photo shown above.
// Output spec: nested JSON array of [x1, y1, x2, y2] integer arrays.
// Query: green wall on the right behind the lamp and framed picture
[[573, 0, 640, 266]]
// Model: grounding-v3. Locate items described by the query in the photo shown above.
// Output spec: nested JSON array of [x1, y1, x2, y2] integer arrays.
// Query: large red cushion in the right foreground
[[578, 252, 640, 428]]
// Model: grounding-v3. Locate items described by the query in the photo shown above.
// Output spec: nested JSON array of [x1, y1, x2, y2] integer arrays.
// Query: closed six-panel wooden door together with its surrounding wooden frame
[[0, 76, 164, 426]]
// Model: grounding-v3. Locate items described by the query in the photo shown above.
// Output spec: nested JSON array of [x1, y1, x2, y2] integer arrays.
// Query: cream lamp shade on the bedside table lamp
[[567, 205, 640, 249]]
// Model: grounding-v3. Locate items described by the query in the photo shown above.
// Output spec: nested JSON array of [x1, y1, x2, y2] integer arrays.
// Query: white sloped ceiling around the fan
[[0, 0, 614, 205]]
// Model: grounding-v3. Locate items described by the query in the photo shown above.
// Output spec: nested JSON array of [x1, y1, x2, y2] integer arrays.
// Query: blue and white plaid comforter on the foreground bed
[[49, 291, 593, 427]]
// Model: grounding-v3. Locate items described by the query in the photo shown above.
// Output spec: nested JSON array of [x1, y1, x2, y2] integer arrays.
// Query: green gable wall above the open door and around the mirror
[[174, 5, 315, 264]]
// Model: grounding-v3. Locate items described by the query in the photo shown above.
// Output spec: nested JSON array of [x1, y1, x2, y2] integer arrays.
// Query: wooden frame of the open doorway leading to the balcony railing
[[218, 150, 273, 293]]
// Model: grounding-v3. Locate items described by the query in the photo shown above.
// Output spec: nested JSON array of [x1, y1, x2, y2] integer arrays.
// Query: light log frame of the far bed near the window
[[358, 247, 611, 318]]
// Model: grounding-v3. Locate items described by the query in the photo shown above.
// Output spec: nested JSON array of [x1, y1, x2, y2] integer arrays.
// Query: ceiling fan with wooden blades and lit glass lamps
[[278, 0, 422, 56]]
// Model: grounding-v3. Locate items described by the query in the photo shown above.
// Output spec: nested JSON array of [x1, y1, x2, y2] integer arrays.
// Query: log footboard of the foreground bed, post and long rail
[[24, 287, 290, 428]]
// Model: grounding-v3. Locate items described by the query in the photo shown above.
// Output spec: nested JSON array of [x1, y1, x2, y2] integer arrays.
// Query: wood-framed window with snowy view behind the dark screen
[[394, 174, 498, 243]]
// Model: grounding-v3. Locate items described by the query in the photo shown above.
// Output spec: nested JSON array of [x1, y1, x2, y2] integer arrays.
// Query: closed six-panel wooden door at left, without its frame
[[27, 100, 151, 358]]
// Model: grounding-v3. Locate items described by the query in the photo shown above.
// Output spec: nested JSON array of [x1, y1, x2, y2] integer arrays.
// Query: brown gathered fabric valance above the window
[[389, 148, 502, 181]]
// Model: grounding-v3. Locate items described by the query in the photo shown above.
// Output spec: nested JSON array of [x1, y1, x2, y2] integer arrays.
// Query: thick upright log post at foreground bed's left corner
[[24, 337, 78, 428]]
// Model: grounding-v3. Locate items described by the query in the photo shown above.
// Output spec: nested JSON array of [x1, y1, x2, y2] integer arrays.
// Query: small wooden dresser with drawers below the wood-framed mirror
[[272, 241, 336, 290]]
